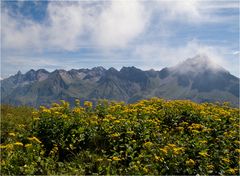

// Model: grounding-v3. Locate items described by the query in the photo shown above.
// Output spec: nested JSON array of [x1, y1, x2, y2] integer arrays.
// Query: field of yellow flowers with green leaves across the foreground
[[0, 98, 240, 175]]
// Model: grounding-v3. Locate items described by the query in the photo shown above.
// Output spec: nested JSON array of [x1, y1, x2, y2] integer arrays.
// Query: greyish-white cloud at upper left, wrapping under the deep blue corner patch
[[2, 2, 86, 50]]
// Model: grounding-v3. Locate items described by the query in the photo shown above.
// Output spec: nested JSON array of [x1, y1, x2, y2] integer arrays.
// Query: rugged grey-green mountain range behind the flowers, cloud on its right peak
[[1, 55, 239, 107]]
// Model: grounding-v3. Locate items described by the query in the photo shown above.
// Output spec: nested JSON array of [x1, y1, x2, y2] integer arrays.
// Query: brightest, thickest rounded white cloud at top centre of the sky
[[94, 0, 148, 48]]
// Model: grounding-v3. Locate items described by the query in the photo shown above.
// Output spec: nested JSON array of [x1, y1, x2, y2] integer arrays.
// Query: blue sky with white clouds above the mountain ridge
[[0, 0, 240, 79]]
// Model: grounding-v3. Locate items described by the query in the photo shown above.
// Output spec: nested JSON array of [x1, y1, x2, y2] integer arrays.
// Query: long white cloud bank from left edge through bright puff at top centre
[[2, 0, 148, 51]]
